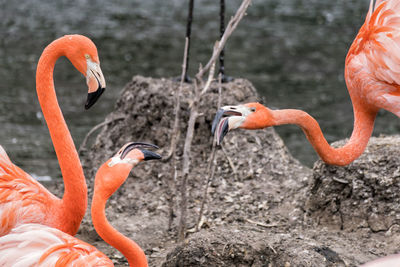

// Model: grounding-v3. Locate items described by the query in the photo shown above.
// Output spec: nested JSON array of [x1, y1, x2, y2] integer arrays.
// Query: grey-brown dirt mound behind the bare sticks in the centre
[[82, 76, 311, 266]]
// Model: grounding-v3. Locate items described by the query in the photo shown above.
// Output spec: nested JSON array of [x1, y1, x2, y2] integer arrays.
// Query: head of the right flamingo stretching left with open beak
[[211, 103, 273, 145]]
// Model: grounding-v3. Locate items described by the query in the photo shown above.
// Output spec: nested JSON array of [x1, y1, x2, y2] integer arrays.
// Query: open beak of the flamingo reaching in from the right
[[211, 106, 248, 145]]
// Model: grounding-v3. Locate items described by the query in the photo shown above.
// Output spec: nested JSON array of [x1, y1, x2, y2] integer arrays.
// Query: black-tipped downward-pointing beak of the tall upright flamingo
[[85, 59, 106, 109]]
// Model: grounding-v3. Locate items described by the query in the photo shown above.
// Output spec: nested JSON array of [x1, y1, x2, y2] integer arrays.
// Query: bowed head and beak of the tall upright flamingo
[[60, 34, 106, 109]]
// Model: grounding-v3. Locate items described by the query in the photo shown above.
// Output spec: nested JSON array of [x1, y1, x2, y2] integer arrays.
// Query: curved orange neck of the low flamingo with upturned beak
[[91, 171, 148, 267]]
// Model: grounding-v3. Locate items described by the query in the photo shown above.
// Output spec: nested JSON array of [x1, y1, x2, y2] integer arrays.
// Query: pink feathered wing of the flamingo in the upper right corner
[[346, 0, 400, 116]]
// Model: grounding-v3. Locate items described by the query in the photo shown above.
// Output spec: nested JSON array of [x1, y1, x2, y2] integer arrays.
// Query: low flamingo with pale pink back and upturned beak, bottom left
[[0, 142, 161, 267]]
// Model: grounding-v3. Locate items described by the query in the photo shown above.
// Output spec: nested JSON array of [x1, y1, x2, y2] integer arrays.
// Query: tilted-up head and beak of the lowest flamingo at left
[[95, 142, 161, 198]]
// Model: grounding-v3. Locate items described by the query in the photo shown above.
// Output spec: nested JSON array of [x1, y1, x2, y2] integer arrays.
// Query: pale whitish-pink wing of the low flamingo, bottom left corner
[[0, 224, 114, 267]]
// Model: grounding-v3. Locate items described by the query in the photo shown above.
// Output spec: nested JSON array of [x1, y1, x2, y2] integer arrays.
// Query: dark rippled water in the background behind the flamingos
[[0, 0, 400, 180]]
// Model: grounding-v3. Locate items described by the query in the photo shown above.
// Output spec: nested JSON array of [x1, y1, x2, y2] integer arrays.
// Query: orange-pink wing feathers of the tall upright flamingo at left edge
[[0, 146, 58, 236]]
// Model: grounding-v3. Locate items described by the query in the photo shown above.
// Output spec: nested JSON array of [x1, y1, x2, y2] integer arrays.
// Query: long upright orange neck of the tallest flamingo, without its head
[[36, 38, 87, 235]]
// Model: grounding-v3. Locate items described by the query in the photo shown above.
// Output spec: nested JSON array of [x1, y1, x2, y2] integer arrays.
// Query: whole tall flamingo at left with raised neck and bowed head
[[0, 35, 105, 236]]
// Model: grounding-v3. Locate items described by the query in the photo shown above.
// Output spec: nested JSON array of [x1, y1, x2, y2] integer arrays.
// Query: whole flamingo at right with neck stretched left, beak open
[[212, 0, 400, 166]]
